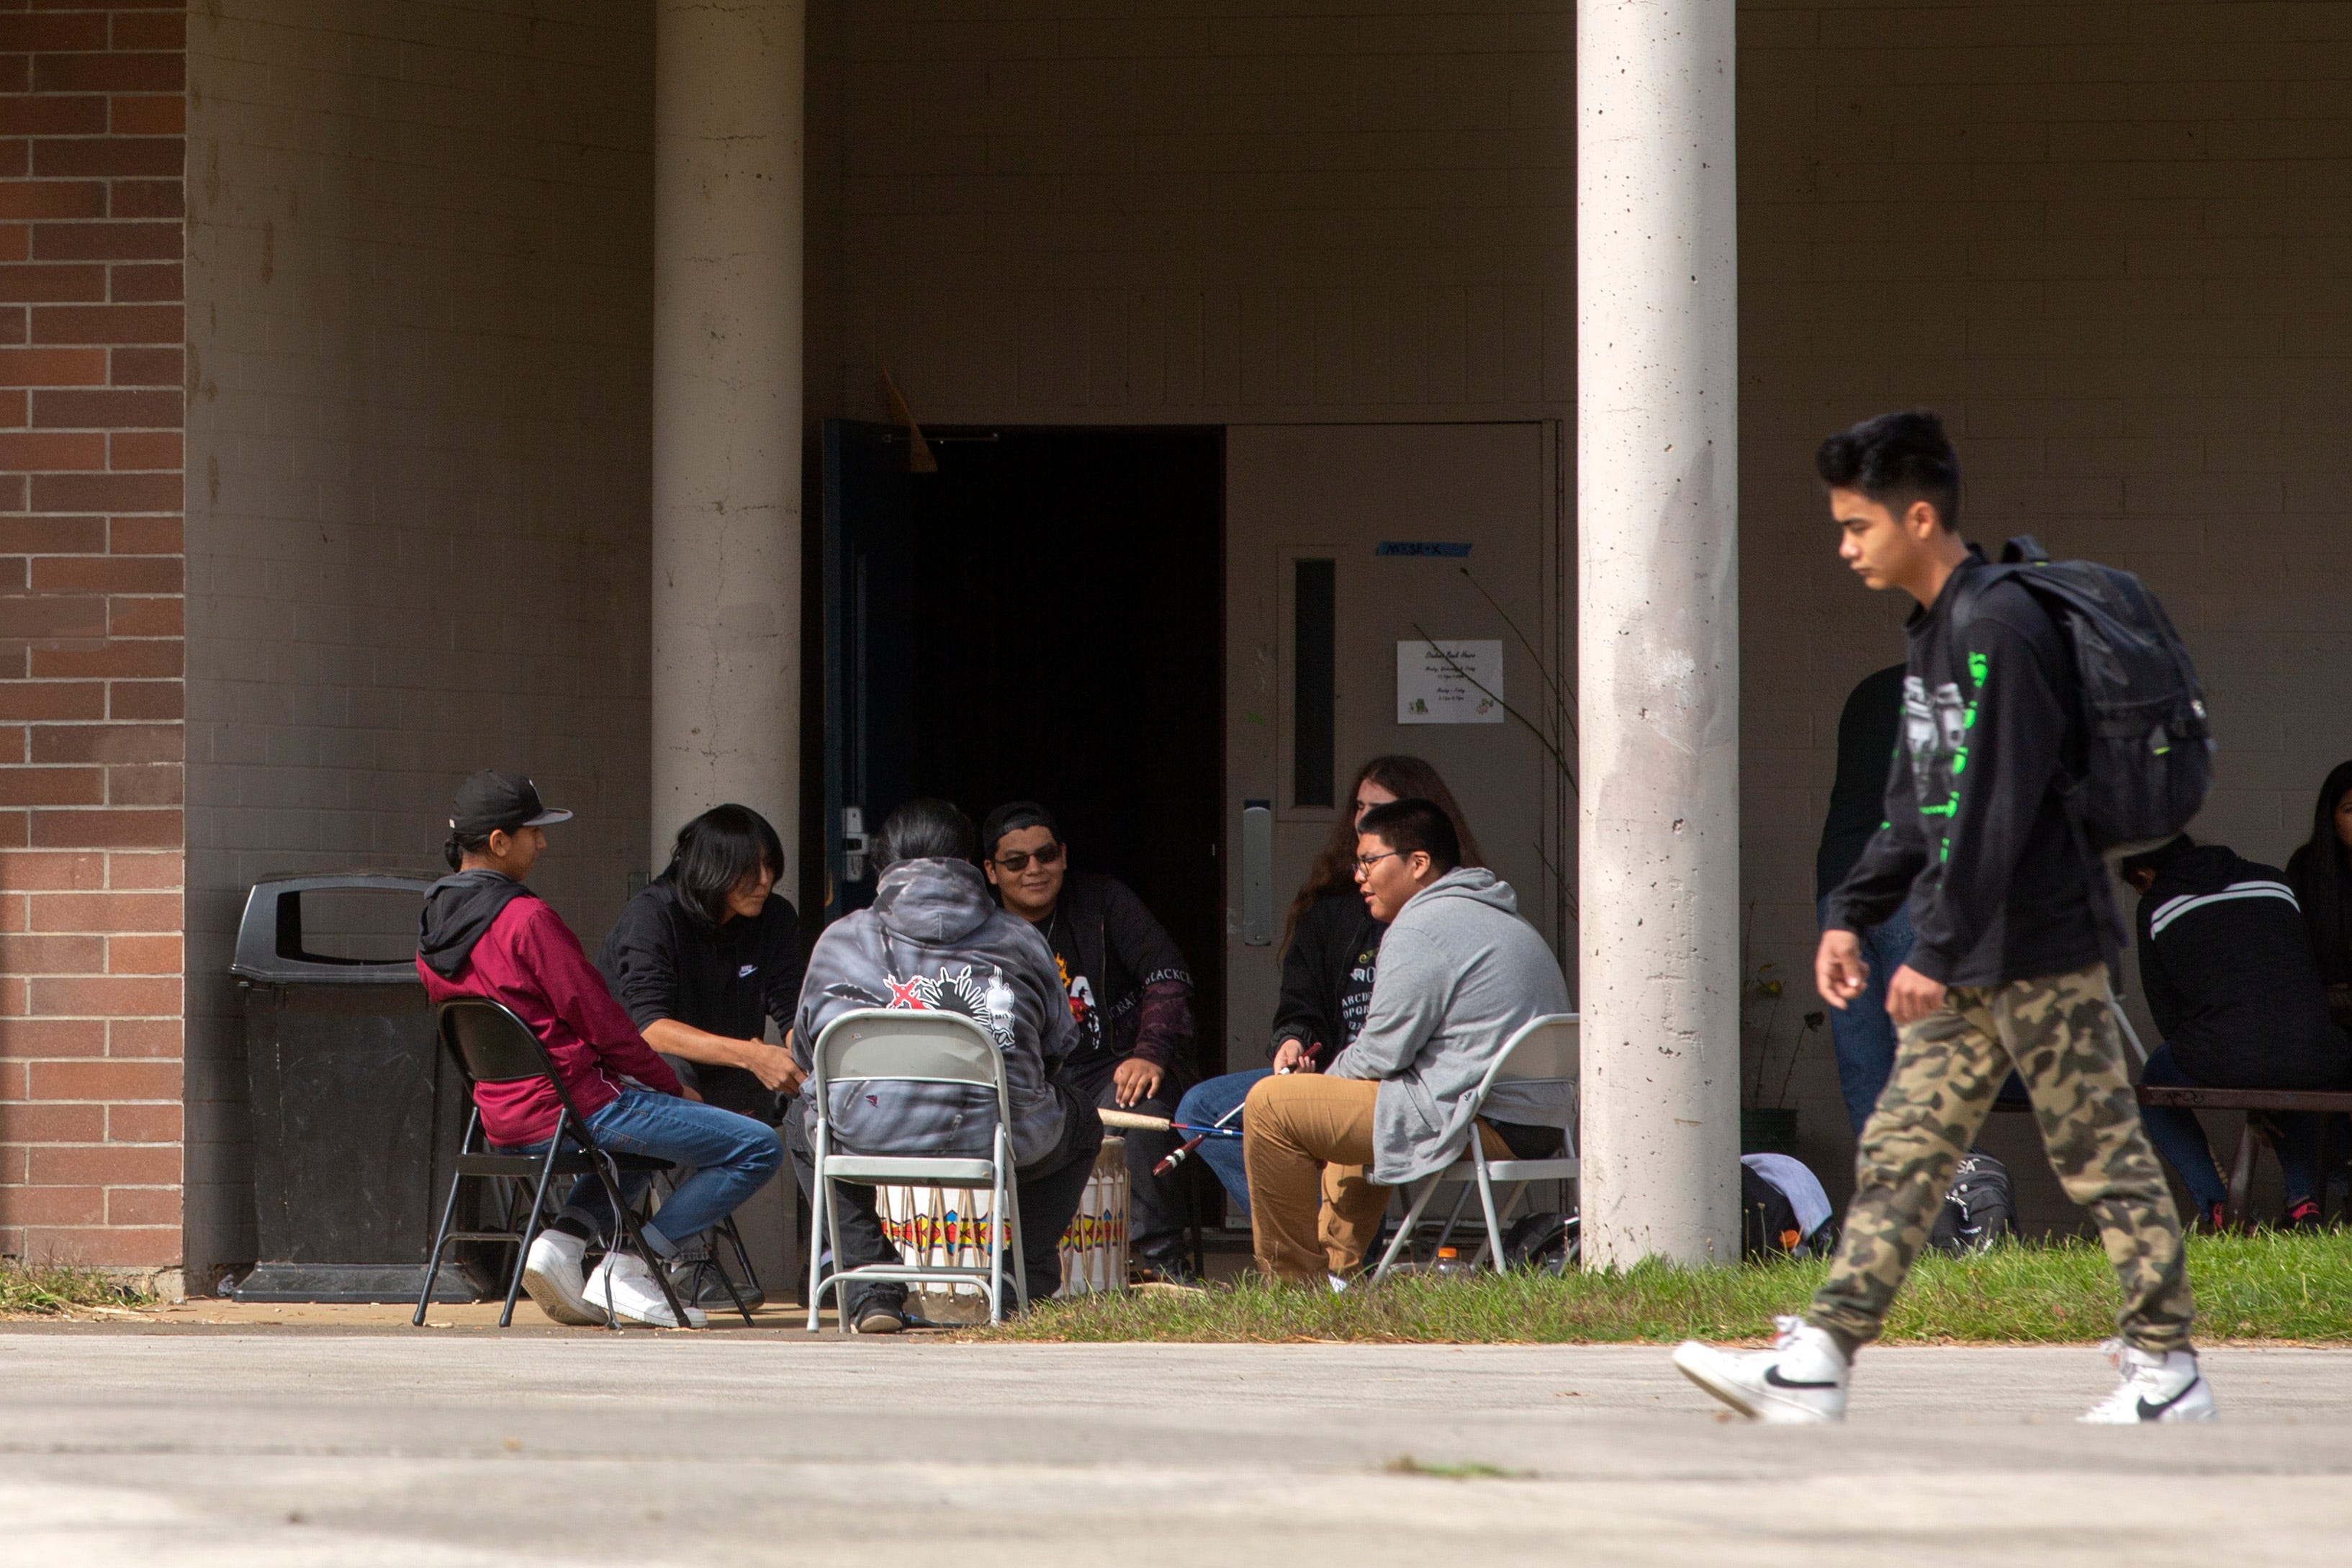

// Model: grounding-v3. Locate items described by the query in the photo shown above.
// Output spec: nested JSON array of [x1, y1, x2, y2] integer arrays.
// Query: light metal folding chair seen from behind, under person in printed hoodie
[[809, 1009, 1028, 1333]]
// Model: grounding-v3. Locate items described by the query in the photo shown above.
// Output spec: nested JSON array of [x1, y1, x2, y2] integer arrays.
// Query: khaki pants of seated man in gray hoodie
[[1242, 1072, 1508, 1284]]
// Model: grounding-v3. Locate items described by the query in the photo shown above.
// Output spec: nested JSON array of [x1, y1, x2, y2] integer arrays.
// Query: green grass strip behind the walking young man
[[971, 1232, 2352, 1345]]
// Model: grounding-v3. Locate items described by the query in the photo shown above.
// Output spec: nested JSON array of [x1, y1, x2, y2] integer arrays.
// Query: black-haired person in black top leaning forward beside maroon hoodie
[[598, 806, 804, 1126]]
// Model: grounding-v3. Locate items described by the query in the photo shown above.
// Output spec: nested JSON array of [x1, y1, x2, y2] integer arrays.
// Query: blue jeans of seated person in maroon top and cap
[[505, 1089, 783, 1258]]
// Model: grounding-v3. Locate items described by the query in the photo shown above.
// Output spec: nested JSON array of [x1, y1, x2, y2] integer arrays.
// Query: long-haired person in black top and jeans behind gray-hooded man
[[1176, 754, 1487, 1215]]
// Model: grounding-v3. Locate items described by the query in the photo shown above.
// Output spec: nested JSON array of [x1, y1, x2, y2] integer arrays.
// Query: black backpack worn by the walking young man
[[1952, 533, 2213, 853]]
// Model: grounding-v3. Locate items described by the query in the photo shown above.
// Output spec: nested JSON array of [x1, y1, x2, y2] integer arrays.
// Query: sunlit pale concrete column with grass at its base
[[1576, 0, 1741, 1265]]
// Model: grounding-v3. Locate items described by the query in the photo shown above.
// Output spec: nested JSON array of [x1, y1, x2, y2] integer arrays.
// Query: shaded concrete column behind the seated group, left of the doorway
[[652, 0, 807, 870]]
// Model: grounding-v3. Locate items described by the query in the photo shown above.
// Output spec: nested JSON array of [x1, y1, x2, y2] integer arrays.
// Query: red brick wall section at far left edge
[[0, 0, 184, 1267]]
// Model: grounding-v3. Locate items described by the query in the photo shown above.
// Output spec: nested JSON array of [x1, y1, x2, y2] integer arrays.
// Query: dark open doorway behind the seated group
[[826, 428, 1225, 1072]]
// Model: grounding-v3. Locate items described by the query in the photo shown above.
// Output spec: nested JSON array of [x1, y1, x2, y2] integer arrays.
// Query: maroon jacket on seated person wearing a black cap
[[416, 877, 680, 1147]]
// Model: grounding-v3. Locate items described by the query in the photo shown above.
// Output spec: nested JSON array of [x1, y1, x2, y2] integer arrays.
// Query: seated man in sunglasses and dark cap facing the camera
[[981, 799, 1192, 1281]]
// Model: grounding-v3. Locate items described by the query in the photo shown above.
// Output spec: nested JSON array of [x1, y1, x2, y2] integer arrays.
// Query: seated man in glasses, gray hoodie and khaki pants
[[1242, 799, 1574, 1286]]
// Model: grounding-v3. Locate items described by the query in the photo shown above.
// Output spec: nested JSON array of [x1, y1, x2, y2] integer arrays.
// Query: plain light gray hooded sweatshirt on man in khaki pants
[[1327, 868, 1576, 1187]]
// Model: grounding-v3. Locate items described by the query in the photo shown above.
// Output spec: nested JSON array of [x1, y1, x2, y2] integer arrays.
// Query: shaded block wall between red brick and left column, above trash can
[[188, 0, 654, 1269]]
